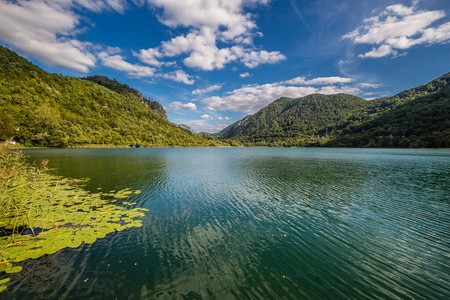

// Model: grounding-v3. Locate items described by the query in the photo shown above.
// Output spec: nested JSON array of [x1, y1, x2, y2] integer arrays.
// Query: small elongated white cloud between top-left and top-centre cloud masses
[[98, 51, 155, 77]]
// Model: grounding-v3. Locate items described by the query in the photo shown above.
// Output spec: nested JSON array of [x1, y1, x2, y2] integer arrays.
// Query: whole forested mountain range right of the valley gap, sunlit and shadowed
[[215, 73, 450, 147]]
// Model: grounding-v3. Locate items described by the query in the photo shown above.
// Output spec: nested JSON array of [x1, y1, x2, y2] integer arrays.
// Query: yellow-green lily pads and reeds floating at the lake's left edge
[[0, 149, 146, 292]]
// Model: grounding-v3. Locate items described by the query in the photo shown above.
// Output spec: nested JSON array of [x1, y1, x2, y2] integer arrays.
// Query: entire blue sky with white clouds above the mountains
[[0, 0, 450, 132]]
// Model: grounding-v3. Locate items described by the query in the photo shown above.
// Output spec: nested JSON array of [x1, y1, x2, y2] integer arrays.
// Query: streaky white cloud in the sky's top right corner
[[343, 3, 450, 58]]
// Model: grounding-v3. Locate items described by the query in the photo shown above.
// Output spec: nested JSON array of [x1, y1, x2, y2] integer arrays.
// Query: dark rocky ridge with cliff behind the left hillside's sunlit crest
[[81, 75, 169, 121]]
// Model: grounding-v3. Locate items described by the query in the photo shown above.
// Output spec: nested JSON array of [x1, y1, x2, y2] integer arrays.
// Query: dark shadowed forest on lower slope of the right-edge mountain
[[329, 82, 450, 148]]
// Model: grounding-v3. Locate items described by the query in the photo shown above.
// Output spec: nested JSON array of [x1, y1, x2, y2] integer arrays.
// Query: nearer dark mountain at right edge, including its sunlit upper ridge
[[329, 73, 450, 148]]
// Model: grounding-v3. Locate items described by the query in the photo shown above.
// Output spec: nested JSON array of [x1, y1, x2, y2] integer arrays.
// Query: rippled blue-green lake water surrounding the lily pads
[[3, 148, 450, 299]]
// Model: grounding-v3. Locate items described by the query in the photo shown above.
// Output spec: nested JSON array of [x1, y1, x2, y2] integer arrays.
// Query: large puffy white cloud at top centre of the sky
[[138, 0, 285, 71]]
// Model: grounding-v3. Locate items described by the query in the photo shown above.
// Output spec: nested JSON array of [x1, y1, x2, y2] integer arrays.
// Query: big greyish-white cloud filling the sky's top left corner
[[0, 0, 134, 73]]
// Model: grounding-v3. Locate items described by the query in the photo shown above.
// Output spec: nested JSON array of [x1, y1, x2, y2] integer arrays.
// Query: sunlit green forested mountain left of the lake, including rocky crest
[[0, 46, 226, 147]]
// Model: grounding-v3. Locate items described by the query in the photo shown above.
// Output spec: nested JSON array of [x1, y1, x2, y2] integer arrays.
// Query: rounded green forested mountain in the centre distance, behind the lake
[[218, 94, 368, 146]]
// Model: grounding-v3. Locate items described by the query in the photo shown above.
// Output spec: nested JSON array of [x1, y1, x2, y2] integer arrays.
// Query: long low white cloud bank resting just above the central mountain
[[201, 77, 361, 114]]
